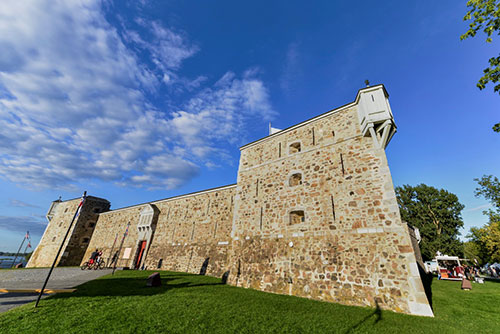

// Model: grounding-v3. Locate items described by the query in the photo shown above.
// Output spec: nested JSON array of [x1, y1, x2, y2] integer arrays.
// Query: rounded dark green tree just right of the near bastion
[[396, 184, 464, 260]]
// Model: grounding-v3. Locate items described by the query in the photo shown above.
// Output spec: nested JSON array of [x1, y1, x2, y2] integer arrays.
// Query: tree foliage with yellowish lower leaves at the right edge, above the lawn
[[467, 175, 500, 264]]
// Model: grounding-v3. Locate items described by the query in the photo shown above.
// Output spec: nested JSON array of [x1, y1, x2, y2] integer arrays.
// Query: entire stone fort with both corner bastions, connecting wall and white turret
[[28, 85, 433, 316]]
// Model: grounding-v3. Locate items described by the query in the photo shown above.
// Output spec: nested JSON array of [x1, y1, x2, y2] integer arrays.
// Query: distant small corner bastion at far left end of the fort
[[26, 196, 110, 267]]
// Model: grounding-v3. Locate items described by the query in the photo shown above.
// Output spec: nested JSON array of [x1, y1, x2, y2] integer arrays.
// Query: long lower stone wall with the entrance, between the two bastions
[[84, 185, 236, 276]]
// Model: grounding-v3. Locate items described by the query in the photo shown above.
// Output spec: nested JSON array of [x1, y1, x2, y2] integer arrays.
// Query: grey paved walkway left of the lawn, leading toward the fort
[[0, 268, 111, 313]]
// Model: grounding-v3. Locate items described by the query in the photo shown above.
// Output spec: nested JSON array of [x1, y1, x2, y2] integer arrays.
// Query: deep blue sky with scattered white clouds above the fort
[[0, 0, 500, 251]]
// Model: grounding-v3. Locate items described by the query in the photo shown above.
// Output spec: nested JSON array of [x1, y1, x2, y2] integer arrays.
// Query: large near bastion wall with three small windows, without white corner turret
[[229, 101, 432, 315]]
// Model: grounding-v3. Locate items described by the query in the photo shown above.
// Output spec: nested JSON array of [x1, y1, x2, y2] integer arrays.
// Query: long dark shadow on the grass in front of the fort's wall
[[50, 275, 223, 299]]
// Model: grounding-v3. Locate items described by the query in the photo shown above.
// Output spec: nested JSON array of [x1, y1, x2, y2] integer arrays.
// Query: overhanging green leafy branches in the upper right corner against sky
[[460, 0, 500, 132]]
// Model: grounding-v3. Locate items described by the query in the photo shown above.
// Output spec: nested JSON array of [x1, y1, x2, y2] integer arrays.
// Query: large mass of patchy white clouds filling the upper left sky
[[0, 0, 274, 188]]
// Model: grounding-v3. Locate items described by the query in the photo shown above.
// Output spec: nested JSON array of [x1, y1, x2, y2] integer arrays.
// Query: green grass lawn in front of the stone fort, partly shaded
[[0, 271, 500, 334]]
